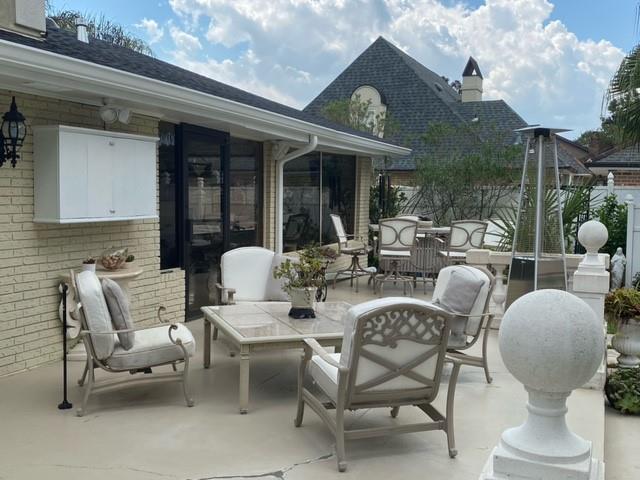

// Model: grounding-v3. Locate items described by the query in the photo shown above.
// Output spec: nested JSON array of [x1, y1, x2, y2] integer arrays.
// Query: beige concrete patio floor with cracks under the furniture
[[0, 282, 640, 480]]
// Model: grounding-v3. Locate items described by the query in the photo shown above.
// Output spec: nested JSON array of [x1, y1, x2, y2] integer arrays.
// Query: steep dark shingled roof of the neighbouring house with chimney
[[304, 37, 527, 171]]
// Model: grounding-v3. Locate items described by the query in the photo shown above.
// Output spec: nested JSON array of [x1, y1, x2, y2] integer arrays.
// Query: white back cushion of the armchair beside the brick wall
[[75, 271, 115, 360]]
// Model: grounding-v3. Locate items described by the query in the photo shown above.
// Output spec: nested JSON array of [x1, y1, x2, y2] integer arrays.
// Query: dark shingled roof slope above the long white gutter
[[0, 22, 404, 153]]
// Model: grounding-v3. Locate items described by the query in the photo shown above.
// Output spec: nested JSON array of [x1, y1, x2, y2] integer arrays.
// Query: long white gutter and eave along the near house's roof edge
[[0, 40, 411, 156]]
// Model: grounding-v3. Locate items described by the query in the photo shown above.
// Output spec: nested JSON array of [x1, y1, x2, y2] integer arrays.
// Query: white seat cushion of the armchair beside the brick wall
[[105, 323, 196, 370]]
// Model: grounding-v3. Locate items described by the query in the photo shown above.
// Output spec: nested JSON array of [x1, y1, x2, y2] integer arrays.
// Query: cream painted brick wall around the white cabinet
[[0, 90, 185, 376]]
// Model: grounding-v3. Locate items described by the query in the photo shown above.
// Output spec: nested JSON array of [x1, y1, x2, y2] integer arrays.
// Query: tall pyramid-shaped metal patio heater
[[506, 126, 568, 307]]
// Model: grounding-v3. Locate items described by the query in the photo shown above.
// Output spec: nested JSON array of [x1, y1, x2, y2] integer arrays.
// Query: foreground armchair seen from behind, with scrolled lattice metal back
[[295, 297, 460, 472]]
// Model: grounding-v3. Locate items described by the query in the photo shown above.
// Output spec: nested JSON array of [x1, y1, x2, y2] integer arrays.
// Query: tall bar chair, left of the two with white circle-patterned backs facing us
[[374, 218, 418, 296]]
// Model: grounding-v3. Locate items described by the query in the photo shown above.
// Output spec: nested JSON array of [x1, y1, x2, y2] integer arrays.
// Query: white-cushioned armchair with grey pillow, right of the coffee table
[[431, 265, 495, 383]]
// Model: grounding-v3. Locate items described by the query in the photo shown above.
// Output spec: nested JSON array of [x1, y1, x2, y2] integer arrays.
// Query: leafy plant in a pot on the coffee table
[[273, 246, 324, 318]]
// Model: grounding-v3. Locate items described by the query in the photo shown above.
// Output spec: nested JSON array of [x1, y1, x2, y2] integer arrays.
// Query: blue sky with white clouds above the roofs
[[52, 0, 639, 136]]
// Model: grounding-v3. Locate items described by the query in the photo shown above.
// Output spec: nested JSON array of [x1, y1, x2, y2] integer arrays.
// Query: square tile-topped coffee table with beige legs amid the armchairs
[[201, 302, 351, 413]]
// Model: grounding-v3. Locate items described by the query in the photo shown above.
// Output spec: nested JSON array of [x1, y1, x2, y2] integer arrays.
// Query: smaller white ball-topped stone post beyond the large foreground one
[[573, 220, 609, 390]]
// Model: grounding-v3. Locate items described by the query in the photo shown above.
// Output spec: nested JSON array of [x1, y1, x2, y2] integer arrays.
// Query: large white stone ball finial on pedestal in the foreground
[[480, 290, 604, 480]]
